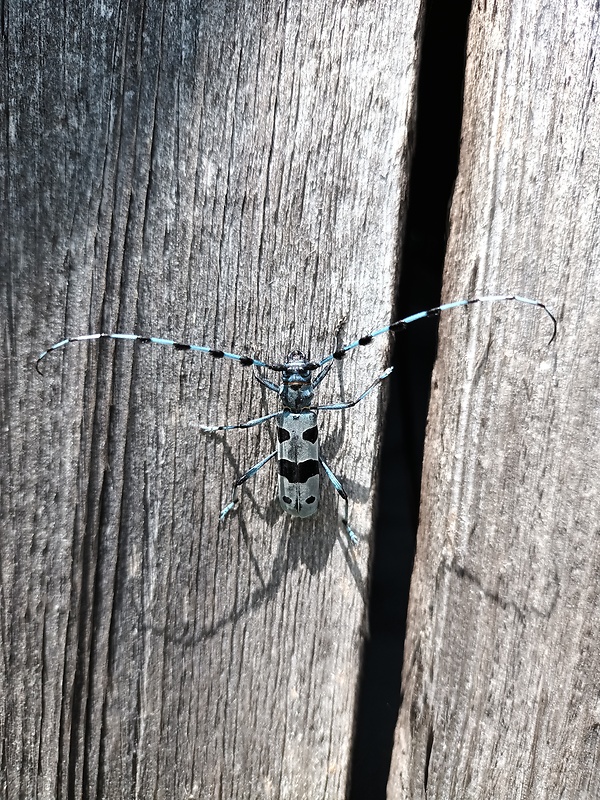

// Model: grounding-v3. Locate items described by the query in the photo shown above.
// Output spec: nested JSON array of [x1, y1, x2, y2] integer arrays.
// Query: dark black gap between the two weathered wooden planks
[[347, 0, 471, 800]]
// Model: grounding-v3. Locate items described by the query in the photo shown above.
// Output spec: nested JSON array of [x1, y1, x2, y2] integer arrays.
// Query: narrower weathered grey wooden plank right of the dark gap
[[388, 0, 600, 800]]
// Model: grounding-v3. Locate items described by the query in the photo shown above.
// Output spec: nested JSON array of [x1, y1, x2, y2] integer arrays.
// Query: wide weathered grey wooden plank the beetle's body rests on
[[0, 0, 419, 800]]
